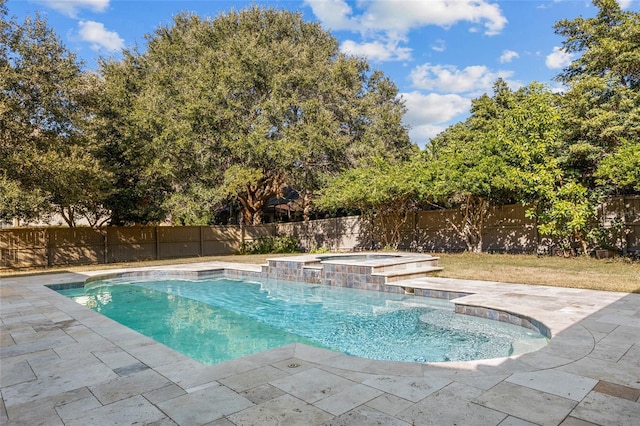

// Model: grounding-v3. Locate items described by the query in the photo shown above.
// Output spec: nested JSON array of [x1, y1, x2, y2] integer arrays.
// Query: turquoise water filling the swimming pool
[[59, 278, 546, 364]]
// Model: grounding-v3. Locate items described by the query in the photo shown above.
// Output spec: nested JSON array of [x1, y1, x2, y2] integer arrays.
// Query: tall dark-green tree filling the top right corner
[[555, 0, 640, 189]]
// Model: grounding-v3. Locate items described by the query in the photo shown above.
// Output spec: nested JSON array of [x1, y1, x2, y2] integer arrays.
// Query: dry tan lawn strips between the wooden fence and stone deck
[[0, 253, 640, 293]]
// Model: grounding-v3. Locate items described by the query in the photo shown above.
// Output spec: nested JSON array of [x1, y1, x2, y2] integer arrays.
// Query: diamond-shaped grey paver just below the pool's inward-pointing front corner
[[270, 368, 354, 403]]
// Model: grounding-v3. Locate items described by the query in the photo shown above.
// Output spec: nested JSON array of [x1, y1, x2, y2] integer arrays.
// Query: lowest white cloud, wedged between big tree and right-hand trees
[[401, 91, 471, 147]]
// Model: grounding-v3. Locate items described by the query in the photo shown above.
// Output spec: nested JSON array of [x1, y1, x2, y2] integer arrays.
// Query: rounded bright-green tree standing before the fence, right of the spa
[[423, 80, 561, 252]]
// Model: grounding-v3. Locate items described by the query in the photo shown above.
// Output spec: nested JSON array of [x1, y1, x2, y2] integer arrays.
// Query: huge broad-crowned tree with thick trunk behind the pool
[[101, 7, 410, 224]]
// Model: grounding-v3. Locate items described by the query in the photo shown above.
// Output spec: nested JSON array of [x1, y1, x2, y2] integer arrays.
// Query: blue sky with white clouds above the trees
[[6, 0, 640, 146]]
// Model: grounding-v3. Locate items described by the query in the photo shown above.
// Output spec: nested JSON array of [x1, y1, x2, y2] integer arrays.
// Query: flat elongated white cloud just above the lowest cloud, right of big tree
[[409, 63, 513, 93]]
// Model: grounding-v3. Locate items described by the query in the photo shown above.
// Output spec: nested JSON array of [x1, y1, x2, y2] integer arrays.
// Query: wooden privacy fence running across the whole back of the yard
[[0, 197, 640, 270]]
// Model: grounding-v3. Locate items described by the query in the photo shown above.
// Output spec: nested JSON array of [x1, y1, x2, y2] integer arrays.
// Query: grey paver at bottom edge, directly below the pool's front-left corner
[[158, 385, 253, 425]]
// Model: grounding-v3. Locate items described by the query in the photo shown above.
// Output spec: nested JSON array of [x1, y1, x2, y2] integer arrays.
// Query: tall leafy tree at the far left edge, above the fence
[[0, 6, 111, 226]]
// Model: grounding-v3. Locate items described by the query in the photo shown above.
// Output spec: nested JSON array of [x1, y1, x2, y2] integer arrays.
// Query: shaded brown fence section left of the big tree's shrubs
[[0, 224, 275, 269]]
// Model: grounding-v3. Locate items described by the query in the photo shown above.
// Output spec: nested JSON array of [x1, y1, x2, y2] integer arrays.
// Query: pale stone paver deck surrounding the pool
[[0, 263, 640, 426]]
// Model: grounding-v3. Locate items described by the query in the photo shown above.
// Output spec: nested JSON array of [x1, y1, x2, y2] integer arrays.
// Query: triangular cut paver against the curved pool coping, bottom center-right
[[363, 376, 451, 402]]
